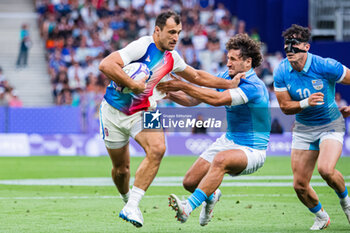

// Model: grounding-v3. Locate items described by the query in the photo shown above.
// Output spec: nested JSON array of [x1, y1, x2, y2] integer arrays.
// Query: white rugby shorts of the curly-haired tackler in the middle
[[200, 134, 266, 175]]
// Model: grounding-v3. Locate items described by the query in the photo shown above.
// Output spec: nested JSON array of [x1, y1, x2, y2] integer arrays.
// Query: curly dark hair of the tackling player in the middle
[[226, 34, 263, 68]]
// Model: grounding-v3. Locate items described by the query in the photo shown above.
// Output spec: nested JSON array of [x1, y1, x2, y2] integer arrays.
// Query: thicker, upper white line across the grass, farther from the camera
[[0, 176, 350, 187]]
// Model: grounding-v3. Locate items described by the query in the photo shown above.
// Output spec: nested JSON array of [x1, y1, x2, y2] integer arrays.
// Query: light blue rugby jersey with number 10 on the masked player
[[273, 53, 346, 126]]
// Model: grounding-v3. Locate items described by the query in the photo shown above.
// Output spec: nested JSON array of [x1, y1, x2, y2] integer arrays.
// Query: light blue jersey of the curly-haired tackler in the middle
[[217, 69, 271, 150]]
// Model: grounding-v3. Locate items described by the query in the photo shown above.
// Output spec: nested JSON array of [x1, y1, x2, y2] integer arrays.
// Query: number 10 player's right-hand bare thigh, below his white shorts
[[318, 139, 343, 169]]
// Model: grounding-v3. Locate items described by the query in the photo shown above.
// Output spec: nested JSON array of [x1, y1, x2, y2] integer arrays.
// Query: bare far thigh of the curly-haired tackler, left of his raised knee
[[184, 157, 210, 184]]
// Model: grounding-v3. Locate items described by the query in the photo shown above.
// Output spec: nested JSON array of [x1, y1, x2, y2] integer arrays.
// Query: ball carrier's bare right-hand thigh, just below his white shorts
[[135, 129, 165, 155]]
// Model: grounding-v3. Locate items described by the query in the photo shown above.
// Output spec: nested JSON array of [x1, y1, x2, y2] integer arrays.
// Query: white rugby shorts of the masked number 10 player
[[292, 116, 345, 150]]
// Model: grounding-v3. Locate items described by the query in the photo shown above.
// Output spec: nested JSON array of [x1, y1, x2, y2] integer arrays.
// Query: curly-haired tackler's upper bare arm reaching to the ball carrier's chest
[[157, 80, 232, 106]]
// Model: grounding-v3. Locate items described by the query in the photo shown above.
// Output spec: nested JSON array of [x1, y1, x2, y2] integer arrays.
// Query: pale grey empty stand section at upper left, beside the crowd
[[0, 0, 53, 106]]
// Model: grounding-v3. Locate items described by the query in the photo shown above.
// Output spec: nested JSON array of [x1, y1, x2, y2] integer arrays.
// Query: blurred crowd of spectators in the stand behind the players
[[31, 0, 348, 134]]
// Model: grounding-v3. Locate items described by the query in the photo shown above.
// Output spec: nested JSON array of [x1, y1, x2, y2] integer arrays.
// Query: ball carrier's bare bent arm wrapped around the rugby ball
[[98, 51, 148, 94]]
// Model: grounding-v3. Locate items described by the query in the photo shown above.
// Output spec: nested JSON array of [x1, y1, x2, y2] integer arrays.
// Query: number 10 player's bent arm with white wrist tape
[[275, 91, 324, 115]]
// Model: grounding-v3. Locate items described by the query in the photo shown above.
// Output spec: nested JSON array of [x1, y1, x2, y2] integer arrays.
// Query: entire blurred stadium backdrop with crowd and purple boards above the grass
[[0, 0, 350, 155]]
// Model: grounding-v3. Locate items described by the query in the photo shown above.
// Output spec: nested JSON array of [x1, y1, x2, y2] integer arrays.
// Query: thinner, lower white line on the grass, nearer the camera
[[0, 193, 300, 201]]
